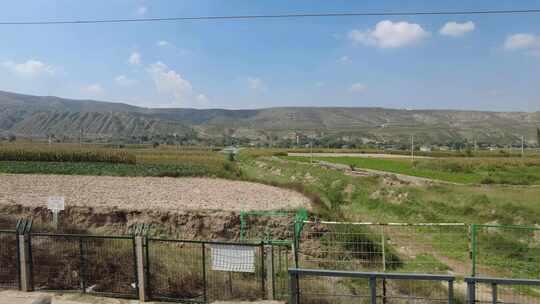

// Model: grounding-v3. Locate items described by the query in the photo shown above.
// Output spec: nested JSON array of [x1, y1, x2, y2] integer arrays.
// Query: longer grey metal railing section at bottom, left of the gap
[[289, 268, 455, 304]]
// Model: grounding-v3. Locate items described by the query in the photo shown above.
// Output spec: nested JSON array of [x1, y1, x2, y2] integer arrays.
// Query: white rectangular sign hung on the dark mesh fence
[[211, 245, 255, 272]]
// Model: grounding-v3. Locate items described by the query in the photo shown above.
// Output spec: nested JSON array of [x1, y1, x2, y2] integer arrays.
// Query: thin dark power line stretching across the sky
[[0, 9, 540, 25]]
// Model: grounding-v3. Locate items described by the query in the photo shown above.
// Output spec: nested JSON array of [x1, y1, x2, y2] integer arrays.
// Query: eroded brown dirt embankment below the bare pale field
[[0, 205, 298, 241]]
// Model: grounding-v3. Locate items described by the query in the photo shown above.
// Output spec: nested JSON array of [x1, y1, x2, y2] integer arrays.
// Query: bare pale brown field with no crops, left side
[[0, 174, 309, 211]]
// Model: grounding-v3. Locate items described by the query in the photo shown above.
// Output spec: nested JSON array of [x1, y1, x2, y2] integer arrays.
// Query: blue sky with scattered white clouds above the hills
[[0, 0, 540, 111]]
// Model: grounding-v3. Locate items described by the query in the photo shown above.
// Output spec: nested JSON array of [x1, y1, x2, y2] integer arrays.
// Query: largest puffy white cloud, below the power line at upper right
[[349, 20, 430, 48]]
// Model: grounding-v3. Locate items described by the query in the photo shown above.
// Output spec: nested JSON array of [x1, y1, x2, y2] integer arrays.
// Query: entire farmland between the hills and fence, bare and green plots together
[[0, 144, 540, 302]]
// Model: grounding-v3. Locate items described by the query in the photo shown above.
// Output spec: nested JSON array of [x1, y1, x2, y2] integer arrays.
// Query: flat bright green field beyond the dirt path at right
[[284, 156, 540, 185]]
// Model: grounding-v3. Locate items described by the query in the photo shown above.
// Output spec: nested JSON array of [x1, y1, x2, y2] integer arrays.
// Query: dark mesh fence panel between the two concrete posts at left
[[30, 234, 137, 297]]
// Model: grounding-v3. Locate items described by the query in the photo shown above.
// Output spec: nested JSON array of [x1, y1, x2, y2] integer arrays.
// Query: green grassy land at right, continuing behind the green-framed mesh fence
[[242, 151, 540, 288]]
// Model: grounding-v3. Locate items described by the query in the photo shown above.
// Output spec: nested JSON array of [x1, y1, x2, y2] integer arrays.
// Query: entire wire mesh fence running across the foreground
[[5, 221, 540, 303]]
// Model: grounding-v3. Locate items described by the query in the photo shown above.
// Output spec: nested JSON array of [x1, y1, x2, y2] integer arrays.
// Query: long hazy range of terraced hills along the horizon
[[0, 91, 540, 144]]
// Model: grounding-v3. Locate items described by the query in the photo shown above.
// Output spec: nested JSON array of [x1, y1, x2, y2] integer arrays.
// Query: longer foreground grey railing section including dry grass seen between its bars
[[290, 269, 460, 304]]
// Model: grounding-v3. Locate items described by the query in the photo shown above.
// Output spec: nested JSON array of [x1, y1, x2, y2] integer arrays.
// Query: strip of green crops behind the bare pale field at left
[[0, 143, 242, 179]]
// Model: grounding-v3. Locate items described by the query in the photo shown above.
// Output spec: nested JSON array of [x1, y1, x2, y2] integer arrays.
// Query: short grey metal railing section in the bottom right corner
[[465, 277, 540, 304]]
